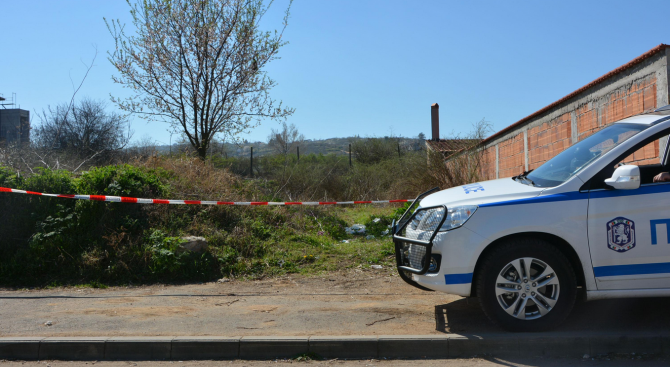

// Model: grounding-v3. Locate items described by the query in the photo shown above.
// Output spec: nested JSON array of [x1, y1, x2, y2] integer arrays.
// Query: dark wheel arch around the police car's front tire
[[470, 232, 586, 297]]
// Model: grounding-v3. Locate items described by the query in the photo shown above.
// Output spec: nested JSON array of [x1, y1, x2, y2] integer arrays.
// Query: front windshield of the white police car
[[517, 123, 648, 187]]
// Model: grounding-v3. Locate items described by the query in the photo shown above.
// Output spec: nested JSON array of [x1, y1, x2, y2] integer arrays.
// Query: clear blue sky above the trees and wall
[[0, 0, 670, 144]]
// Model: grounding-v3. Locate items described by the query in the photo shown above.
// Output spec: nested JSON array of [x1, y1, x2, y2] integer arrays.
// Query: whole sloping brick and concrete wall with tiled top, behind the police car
[[482, 48, 670, 179]]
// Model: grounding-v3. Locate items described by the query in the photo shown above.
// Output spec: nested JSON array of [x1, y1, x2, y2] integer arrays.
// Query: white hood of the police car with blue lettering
[[420, 177, 544, 208]]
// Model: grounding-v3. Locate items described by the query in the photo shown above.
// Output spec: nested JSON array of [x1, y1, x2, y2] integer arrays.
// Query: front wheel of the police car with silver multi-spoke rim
[[476, 237, 577, 331]]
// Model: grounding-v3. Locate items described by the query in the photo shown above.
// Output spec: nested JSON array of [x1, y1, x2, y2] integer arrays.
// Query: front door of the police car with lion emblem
[[587, 131, 670, 290]]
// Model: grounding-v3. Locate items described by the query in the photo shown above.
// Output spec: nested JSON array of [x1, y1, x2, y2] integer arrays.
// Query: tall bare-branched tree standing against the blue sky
[[105, 0, 294, 159]]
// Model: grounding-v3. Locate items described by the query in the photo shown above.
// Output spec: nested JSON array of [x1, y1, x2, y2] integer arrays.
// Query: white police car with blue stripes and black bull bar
[[393, 106, 670, 331]]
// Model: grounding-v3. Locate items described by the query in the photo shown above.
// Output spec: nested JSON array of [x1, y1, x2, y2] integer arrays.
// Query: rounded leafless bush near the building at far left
[[34, 98, 132, 157]]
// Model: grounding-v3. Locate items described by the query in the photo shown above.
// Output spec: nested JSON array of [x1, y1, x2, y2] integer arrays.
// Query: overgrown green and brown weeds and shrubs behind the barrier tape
[[0, 122, 494, 287]]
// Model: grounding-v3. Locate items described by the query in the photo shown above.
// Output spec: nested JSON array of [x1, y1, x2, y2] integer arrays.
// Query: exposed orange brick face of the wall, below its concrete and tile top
[[482, 74, 659, 179]]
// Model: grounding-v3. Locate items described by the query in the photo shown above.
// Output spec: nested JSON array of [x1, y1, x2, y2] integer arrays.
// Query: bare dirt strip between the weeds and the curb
[[0, 268, 670, 336]]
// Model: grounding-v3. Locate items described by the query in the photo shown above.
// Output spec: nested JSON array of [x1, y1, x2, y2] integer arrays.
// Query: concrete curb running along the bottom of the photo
[[0, 333, 670, 361]]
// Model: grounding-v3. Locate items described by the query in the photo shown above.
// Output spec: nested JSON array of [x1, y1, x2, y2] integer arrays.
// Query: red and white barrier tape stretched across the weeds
[[0, 187, 412, 206]]
